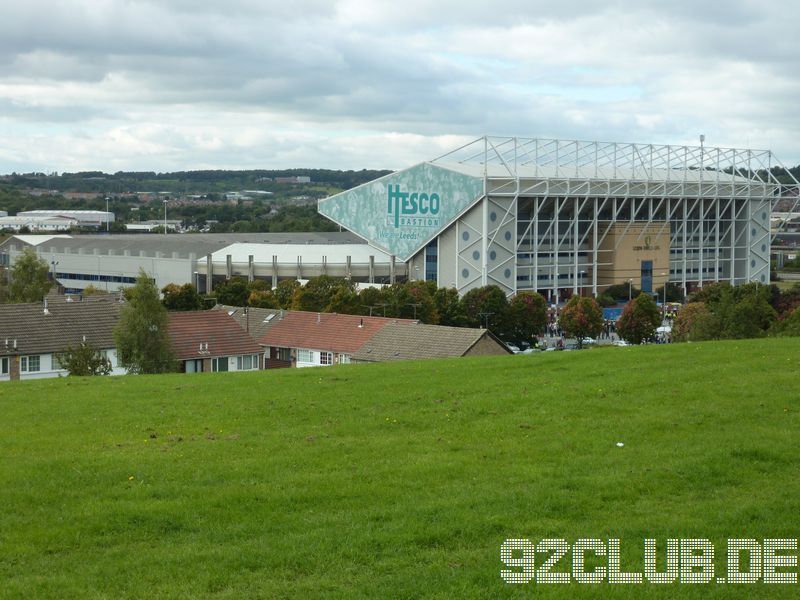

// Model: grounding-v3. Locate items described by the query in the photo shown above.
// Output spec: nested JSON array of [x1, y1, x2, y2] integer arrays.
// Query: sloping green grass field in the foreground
[[0, 339, 800, 598]]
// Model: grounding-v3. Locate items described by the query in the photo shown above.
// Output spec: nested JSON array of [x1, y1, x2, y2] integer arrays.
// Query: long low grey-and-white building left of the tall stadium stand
[[0, 232, 406, 293]]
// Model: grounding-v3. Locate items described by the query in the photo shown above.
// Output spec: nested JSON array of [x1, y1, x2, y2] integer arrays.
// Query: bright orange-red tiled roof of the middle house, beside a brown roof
[[258, 311, 414, 353]]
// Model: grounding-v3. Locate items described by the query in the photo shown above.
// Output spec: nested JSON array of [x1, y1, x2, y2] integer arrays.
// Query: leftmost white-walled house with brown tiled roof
[[0, 295, 126, 381]]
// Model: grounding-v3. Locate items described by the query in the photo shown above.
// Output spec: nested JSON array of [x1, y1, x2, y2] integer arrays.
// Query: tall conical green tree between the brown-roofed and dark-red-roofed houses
[[114, 269, 176, 373]]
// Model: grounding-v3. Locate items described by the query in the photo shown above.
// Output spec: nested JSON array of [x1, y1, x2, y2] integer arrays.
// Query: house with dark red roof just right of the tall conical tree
[[169, 310, 262, 373]]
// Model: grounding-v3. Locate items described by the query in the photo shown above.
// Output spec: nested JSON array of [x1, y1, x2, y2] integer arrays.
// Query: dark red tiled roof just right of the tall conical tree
[[169, 310, 261, 360]]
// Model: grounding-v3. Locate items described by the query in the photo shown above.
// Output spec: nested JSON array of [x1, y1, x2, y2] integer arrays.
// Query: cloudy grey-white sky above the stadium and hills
[[0, 0, 800, 173]]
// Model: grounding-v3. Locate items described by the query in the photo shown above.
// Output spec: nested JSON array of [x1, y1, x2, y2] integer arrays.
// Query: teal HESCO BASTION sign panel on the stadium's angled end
[[318, 163, 483, 261]]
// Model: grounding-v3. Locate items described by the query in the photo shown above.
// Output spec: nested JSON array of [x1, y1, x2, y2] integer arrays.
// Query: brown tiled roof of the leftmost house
[[0, 296, 120, 355]]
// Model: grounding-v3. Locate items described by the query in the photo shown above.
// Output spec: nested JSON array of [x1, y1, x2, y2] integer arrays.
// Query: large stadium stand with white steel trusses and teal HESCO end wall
[[318, 136, 797, 301]]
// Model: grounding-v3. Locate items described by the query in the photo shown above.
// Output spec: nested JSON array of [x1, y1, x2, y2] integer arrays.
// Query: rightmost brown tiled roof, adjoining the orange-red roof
[[352, 323, 507, 361]]
